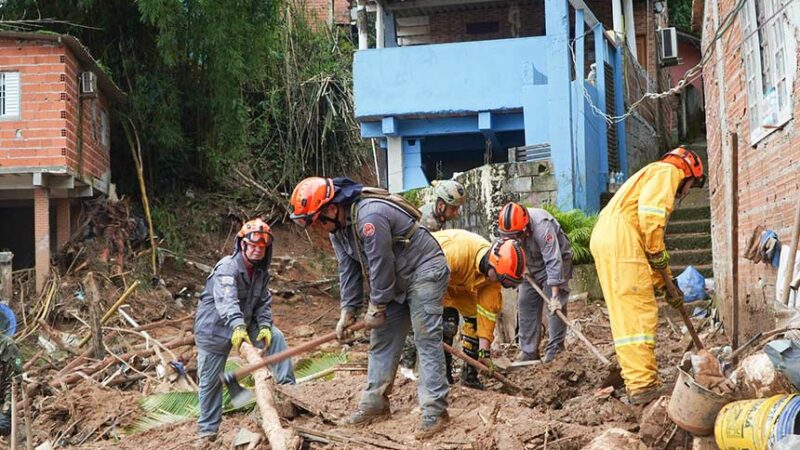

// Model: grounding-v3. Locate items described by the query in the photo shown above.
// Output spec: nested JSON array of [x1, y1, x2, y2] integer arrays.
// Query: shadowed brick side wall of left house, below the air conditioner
[[66, 54, 111, 178]]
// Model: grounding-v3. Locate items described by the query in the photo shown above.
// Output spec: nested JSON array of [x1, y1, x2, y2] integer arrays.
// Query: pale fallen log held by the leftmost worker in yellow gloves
[[239, 342, 302, 450]]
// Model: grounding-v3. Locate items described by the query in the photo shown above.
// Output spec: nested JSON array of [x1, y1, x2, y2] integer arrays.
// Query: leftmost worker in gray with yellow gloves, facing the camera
[[194, 219, 295, 441]]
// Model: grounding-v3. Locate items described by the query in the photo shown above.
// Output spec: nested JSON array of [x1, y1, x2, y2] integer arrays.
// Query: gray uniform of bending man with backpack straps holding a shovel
[[331, 199, 450, 417]]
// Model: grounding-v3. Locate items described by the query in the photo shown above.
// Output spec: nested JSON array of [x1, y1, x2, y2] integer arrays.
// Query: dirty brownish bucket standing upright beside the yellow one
[[667, 368, 731, 436]]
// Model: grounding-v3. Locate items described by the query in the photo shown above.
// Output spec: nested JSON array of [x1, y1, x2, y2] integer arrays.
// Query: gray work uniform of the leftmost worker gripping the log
[[194, 251, 295, 434]]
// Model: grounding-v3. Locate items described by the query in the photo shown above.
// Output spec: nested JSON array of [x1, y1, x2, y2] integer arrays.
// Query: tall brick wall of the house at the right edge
[[703, 0, 800, 342]]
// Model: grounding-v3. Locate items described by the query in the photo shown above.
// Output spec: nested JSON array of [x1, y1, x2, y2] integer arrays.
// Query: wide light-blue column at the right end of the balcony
[[545, 0, 576, 208]]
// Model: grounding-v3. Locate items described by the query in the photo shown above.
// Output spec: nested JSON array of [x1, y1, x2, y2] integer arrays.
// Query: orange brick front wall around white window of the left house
[[0, 39, 66, 168]]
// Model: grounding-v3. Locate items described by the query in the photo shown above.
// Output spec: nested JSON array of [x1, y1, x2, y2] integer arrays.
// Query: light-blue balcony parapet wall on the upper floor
[[353, 36, 547, 119]]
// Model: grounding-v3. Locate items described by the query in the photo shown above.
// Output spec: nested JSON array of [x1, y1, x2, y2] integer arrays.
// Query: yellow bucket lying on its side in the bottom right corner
[[714, 394, 800, 450]]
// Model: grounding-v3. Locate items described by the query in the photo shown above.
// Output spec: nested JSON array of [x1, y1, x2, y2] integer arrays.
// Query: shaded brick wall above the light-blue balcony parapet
[[430, 2, 545, 44]]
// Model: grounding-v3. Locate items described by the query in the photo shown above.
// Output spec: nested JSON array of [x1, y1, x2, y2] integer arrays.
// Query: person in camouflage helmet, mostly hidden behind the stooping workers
[[400, 180, 466, 372]]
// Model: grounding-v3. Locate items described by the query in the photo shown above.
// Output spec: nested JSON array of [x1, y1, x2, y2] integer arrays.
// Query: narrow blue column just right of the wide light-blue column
[[572, 9, 596, 210]]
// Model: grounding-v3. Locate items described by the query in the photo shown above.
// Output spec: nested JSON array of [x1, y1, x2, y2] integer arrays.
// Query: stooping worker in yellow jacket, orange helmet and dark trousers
[[433, 230, 525, 389]]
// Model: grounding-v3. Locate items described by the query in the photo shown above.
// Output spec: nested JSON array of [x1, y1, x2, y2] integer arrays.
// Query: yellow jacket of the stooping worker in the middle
[[433, 230, 503, 344]]
